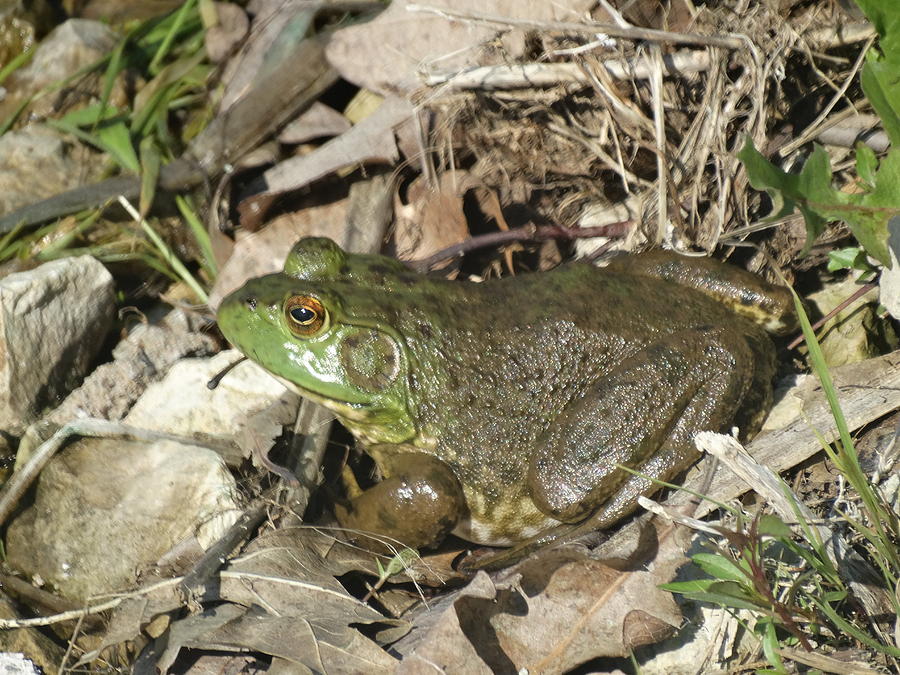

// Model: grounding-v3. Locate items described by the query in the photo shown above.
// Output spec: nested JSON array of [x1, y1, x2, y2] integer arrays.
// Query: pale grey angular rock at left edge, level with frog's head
[[0, 256, 115, 436]]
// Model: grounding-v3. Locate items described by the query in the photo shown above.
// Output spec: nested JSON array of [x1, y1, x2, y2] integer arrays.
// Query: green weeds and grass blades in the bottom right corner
[[663, 294, 900, 673]]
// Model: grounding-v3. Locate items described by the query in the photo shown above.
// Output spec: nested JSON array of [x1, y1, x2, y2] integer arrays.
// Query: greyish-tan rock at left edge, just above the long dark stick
[[0, 124, 99, 214]]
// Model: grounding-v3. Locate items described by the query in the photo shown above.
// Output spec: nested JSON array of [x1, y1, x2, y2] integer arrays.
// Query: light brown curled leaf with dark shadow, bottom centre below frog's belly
[[395, 528, 685, 673]]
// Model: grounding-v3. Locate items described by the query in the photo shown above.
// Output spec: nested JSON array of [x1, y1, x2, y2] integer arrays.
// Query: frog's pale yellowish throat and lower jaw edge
[[270, 373, 416, 443]]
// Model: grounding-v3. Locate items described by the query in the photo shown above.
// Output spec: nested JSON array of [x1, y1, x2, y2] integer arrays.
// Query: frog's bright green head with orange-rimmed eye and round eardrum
[[218, 238, 415, 443]]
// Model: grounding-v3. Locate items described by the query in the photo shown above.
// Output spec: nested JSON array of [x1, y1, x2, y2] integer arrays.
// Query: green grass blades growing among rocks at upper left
[[0, 0, 217, 298]]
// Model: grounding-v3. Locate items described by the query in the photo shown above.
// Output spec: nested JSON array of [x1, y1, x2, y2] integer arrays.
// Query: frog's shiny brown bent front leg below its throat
[[335, 453, 465, 548]]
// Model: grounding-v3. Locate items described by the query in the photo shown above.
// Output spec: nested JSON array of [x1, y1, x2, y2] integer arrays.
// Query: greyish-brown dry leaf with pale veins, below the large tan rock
[[95, 528, 409, 673]]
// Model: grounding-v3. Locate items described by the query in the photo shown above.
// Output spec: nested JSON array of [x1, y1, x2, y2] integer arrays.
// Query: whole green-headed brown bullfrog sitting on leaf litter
[[219, 238, 791, 547]]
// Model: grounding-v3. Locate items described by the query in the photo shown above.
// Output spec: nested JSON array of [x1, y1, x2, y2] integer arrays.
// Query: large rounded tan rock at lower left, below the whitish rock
[[6, 438, 240, 602]]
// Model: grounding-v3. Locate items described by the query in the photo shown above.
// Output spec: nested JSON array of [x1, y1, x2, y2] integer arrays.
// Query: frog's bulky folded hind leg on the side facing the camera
[[529, 327, 753, 524]]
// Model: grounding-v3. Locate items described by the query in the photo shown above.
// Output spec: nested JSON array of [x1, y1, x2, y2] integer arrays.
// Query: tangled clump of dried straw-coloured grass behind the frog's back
[[420, 0, 866, 272]]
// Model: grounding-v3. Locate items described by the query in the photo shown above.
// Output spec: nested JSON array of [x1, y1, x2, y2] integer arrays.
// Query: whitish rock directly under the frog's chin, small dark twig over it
[[125, 351, 300, 464]]
